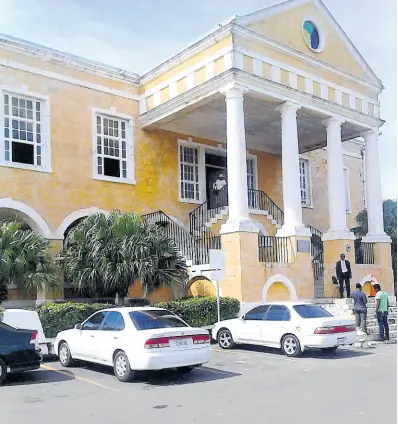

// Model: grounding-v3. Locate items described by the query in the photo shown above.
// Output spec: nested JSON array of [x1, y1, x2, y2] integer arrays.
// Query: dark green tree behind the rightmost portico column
[[352, 199, 397, 293]]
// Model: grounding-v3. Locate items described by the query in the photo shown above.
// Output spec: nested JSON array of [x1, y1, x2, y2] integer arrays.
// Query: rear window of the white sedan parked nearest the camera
[[129, 310, 188, 331]]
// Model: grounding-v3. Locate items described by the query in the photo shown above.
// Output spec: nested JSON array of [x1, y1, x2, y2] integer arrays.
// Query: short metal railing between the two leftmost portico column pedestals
[[258, 235, 292, 263]]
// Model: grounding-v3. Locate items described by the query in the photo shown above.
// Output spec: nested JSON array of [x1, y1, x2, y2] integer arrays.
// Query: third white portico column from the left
[[323, 117, 354, 240]]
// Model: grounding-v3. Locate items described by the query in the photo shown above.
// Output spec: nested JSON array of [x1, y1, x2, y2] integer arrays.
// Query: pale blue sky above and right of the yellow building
[[0, 0, 397, 199]]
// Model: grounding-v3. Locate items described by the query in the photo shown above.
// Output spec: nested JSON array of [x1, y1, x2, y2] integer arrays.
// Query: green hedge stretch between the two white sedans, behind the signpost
[[156, 297, 240, 326]]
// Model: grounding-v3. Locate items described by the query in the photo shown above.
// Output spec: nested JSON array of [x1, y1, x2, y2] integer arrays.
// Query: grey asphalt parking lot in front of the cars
[[0, 345, 397, 424]]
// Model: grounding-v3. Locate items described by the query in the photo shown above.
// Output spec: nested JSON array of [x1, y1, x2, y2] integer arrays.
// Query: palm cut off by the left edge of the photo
[[0, 221, 59, 302]]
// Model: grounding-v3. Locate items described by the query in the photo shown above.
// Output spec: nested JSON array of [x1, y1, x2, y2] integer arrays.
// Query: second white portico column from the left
[[277, 102, 310, 236]]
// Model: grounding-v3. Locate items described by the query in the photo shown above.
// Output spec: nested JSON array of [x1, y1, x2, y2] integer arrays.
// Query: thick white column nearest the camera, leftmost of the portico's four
[[221, 84, 258, 233]]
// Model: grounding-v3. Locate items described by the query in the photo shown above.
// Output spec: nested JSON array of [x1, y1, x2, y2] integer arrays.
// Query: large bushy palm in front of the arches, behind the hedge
[[61, 211, 187, 298]]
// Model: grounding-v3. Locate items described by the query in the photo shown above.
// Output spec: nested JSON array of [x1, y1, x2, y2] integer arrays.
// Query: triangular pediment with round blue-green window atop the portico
[[235, 0, 381, 86]]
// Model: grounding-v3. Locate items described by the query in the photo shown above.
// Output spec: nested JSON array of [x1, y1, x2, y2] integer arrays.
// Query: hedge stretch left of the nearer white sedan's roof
[[35, 302, 113, 338]]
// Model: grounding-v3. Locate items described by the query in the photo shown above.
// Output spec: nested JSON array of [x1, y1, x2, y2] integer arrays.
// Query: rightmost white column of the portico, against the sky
[[362, 128, 391, 242]]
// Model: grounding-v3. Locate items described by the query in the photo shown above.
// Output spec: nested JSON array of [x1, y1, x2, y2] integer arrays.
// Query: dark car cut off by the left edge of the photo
[[0, 322, 42, 385]]
